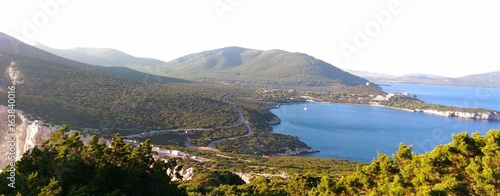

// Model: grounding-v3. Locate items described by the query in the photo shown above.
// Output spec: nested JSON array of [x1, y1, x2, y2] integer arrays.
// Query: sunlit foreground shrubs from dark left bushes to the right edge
[[183, 130, 500, 195]]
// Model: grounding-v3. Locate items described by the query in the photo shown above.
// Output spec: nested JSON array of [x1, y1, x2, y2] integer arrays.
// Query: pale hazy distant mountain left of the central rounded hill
[[34, 43, 165, 66]]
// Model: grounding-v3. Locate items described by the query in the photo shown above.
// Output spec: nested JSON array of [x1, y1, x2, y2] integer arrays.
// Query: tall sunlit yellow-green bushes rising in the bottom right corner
[[327, 130, 500, 195]]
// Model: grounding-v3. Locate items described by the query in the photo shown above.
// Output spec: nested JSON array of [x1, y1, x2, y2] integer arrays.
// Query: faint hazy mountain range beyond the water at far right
[[350, 70, 500, 88]]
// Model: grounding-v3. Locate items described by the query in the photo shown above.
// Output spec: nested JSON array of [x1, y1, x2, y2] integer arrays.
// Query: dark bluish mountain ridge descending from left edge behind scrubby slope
[[0, 32, 189, 83]]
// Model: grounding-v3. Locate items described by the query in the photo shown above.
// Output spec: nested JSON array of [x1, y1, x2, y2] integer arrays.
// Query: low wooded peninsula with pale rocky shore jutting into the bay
[[259, 83, 500, 121]]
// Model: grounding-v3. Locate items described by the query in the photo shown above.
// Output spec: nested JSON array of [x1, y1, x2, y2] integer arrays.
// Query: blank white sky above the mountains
[[0, 0, 500, 77]]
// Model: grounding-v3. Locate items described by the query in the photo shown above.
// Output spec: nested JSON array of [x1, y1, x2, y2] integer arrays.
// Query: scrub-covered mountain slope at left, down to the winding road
[[0, 34, 235, 130]]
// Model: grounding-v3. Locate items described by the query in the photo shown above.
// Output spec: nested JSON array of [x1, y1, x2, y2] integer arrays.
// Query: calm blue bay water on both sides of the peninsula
[[271, 84, 500, 162]]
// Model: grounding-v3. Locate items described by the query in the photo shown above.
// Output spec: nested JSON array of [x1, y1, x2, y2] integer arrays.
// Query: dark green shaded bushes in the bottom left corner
[[0, 127, 186, 196]]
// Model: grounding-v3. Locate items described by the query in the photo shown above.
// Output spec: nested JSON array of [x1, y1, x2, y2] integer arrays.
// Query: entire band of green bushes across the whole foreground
[[0, 126, 500, 196]]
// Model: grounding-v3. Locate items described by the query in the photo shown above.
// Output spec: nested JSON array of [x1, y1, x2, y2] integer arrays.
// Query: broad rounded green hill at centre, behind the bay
[[150, 47, 367, 88]]
